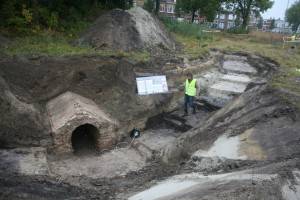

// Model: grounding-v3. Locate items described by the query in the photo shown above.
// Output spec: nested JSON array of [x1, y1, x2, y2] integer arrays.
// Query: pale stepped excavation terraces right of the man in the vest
[[196, 55, 268, 107]]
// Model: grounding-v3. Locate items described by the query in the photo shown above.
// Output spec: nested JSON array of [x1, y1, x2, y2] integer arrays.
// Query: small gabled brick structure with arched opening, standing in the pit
[[47, 92, 117, 153]]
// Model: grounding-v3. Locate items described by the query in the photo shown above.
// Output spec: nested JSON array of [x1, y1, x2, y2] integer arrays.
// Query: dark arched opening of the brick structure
[[71, 124, 99, 154]]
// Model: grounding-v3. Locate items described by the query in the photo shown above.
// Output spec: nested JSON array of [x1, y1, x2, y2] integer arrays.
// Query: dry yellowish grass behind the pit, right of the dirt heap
[[165, 19, 300, 108]]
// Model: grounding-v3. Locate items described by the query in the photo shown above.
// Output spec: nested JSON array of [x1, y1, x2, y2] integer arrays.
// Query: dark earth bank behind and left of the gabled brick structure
[[0, 56, 171, 147]]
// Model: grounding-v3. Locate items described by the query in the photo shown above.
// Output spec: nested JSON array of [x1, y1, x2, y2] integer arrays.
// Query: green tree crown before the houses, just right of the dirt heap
[[176, 0, 222, 22]]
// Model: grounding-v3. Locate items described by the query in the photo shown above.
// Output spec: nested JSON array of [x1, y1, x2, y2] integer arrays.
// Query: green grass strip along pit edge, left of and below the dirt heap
[[0, 33, 150, 61]]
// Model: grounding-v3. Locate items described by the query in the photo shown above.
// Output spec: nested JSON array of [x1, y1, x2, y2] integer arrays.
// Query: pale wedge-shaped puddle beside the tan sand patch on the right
[[194, 135, 247, 160]]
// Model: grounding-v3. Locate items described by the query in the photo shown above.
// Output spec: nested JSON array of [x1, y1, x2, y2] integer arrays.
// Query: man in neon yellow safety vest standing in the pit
[[184, 73, 197, 115]]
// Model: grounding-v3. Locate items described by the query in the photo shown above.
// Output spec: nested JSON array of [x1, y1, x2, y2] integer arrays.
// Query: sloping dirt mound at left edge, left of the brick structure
[[0, 76, 50, 148]]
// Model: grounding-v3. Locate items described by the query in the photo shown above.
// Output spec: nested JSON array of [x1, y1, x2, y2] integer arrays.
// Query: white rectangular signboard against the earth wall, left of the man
[[136, 76, 168, 95]]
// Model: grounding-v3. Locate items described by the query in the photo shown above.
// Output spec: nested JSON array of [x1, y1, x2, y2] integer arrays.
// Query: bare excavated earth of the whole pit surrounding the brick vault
[[0, 48, 300, 200]]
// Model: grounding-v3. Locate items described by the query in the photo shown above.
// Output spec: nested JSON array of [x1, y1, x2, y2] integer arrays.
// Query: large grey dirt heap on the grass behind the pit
[[77, 8, 175, 51]]
